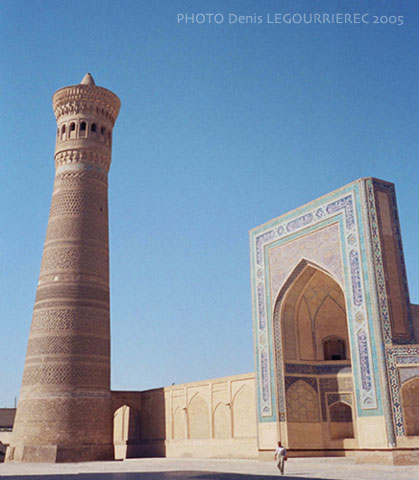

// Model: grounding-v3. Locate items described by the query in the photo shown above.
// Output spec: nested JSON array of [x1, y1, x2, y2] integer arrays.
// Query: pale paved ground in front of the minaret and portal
[[0, 458, 419, 480]]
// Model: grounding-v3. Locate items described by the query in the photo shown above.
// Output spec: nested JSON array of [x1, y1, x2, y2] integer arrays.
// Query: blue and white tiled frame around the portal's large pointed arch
[[250, 180, 388, 422]]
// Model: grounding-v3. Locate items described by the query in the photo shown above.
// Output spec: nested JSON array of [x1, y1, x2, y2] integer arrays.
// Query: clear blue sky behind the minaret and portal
[[0, 0, 419, 407]]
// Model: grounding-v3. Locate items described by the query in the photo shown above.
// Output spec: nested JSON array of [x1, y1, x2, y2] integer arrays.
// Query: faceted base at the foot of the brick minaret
[[5, 444, 114, 463]]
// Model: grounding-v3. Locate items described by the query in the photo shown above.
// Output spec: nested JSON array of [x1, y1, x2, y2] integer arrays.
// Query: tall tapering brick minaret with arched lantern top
[[6, 73, 120, 462]]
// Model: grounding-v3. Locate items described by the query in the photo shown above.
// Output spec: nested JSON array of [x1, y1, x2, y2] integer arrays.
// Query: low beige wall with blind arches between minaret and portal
[[112, 374, 257, 458]]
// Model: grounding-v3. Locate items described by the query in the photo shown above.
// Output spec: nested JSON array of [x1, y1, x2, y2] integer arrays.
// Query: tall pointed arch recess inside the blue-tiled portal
[[273, 260, 355, 449]]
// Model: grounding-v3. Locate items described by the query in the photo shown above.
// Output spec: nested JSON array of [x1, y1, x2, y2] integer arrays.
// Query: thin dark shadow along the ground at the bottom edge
[[1, 471, 330, 480]]
